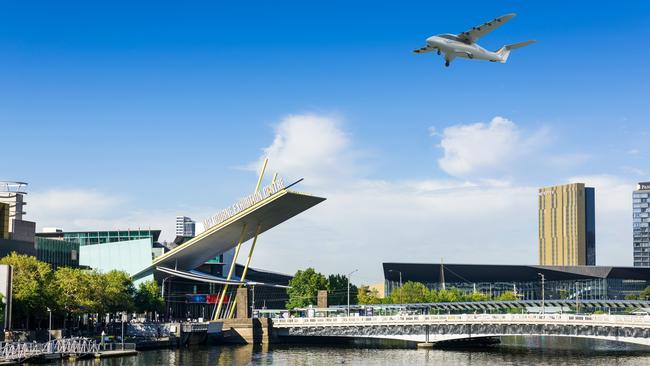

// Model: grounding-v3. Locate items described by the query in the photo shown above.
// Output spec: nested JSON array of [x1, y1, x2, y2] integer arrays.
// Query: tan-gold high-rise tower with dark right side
[[538, 183, 596, 266]]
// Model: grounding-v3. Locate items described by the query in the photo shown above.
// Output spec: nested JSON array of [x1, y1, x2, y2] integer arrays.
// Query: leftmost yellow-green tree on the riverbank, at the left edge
[[0, 252, 55, 328]]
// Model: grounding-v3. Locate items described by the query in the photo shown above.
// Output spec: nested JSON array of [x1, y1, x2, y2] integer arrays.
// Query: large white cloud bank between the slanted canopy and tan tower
[[244, 115, 537, 282]]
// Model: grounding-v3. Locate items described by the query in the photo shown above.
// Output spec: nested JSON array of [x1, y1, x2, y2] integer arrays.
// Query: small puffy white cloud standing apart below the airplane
[[438, 117, 546, 177]]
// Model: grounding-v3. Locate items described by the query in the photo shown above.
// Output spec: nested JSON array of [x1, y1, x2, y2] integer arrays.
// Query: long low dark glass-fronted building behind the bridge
[[384, 263, 650, 300]]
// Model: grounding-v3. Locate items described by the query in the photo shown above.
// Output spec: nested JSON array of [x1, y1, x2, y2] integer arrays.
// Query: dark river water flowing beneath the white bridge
[[52, 337, 650, 366]]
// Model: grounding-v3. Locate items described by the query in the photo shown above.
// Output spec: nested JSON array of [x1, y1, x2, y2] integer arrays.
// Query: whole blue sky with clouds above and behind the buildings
[[0, 1, 650, 280]]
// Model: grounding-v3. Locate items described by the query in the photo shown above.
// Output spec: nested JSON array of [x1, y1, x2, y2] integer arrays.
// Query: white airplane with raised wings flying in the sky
[[413, 13, 535, 66]]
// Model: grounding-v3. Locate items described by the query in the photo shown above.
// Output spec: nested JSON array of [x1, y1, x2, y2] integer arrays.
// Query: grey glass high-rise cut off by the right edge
[[632, 182, 650, 267]]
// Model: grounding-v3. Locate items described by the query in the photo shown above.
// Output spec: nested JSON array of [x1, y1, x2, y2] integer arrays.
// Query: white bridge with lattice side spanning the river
[[273, 314, 650, 346]]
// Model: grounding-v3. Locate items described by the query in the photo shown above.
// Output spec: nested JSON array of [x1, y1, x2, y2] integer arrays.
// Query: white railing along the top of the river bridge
[[273, 314, 650, 328]]
